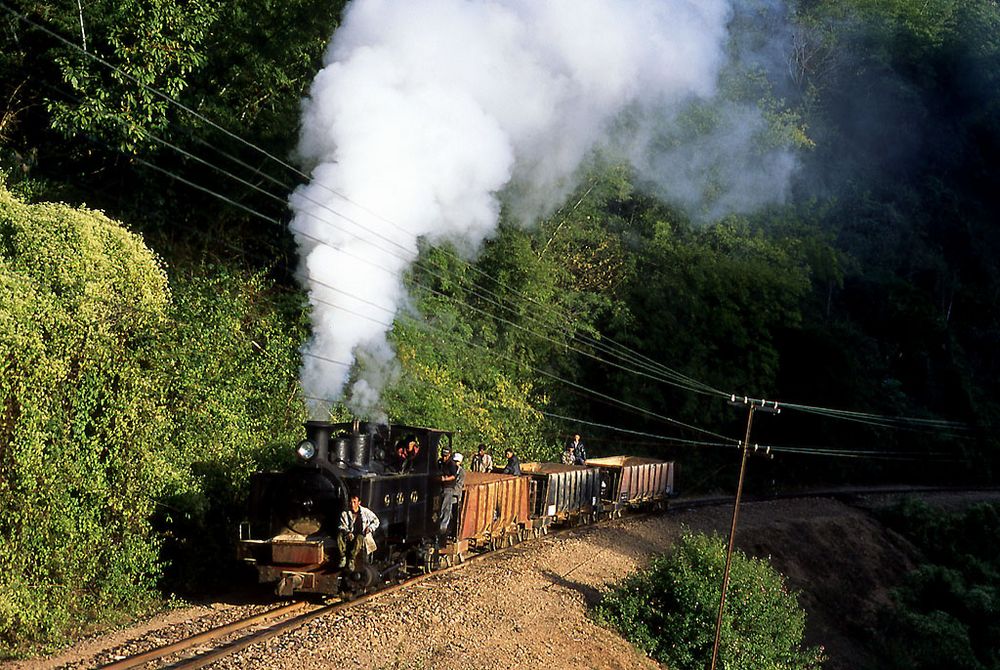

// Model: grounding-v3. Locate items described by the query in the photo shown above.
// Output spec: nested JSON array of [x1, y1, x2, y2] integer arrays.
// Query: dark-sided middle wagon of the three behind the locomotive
[[521, 463, 601, 532]]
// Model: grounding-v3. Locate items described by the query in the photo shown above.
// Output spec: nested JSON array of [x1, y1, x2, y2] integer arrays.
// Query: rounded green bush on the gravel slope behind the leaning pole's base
[[596, 533, 824, 670]]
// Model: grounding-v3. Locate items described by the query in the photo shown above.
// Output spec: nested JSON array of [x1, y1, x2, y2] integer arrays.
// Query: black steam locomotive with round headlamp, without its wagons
[[238, 421, 452, 596]]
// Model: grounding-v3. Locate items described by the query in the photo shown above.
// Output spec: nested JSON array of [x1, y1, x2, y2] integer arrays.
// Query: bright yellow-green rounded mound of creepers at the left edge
[[0, 187, 169, 652]]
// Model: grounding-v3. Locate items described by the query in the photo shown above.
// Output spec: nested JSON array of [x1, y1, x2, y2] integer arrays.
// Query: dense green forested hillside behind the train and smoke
[[0, 0, 1000, 656]]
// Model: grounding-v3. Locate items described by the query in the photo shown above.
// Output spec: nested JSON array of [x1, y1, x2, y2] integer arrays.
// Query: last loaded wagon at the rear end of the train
[[587, 456, 674, 512]]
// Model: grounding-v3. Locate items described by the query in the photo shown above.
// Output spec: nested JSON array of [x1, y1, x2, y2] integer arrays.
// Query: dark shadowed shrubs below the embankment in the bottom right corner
[[876, 501, 1000, 670]]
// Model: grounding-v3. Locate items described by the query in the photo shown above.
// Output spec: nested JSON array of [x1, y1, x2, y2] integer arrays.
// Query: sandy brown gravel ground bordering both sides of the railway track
[[8, 495, 1000, 670]]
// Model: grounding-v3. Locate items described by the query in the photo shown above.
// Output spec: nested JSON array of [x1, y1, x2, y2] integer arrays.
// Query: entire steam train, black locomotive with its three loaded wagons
[[237, 421, 674, 597]]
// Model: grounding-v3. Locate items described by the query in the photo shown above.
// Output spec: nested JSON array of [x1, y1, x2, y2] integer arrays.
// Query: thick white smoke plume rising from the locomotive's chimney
[[291, 0, 788, 416]]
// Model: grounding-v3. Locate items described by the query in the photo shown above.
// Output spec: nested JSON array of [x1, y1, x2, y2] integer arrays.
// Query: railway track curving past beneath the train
[[101, 487, 998, 670]]
